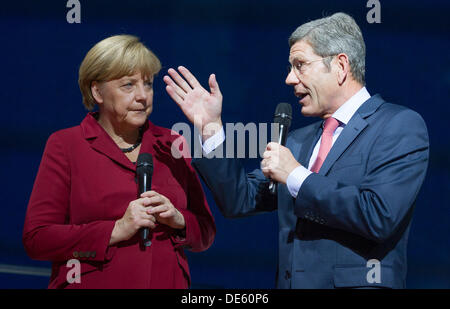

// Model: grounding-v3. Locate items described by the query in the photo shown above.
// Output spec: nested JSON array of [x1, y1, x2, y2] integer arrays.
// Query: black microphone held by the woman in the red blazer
[[136, 153, 153, 247]]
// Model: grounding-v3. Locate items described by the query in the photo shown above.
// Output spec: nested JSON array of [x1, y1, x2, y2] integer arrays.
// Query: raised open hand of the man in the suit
[[163, 66, 222, 140]]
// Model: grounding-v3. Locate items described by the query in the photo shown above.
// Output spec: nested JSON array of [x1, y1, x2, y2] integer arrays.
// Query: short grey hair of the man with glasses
[[289, 13, 366, 85]]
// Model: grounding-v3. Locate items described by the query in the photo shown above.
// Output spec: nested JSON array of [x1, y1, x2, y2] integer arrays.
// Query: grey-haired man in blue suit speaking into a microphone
[[164, 13, 429, 288]]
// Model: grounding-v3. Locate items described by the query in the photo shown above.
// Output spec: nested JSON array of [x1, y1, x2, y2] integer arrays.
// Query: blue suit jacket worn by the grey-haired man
[[193, 95, 429, 288]]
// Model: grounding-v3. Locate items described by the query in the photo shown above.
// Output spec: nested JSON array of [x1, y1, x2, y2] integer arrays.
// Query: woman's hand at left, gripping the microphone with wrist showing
[[109, 197, 156, 245]]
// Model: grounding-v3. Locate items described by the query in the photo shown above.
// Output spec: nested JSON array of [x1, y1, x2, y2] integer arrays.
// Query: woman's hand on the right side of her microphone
[[141, 191, 186, 229]]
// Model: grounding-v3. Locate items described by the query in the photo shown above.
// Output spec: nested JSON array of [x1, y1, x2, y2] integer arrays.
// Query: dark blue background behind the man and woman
[[0, 0, 450, 288]]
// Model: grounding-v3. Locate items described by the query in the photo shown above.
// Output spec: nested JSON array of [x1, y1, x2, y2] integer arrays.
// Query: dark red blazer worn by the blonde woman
[[23, 113, 216, 288]]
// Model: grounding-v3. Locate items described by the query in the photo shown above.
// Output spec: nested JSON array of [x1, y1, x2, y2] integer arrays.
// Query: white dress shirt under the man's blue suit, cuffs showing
[[200, 87, 370, 197]]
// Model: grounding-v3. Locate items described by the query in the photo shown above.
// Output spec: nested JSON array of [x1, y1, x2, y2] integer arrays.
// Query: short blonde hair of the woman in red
[[78, 35, 161, 110]]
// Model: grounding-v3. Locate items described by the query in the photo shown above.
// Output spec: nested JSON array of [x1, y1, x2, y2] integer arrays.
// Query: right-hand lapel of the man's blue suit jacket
[[319, 95, 384, 175]]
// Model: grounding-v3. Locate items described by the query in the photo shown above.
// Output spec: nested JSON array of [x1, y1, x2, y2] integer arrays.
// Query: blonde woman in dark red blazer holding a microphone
[[23, 35, 215, 288]]
